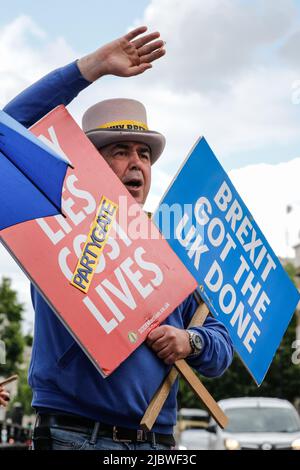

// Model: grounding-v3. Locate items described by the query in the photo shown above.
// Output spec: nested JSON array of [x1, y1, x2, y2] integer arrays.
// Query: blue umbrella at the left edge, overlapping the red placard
[[0, 110, 69, 230]]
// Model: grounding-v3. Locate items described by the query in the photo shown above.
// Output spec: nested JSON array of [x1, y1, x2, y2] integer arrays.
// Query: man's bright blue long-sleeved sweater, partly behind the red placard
[[4, 62, 233, 434]]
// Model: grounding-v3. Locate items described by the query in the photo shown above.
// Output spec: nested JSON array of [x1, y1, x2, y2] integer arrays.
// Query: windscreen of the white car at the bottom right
[[225, 407, 300, 433]]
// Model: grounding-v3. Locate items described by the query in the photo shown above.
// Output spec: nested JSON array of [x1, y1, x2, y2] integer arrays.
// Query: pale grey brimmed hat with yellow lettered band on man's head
[[82, 98, 166, 164]]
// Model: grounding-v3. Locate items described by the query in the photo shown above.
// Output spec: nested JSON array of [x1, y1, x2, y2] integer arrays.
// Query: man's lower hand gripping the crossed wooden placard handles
[[147, 325, 192, 365]]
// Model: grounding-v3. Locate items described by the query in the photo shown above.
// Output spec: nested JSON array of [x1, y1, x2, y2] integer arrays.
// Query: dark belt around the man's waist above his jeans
[[35, 413, 175, 447]]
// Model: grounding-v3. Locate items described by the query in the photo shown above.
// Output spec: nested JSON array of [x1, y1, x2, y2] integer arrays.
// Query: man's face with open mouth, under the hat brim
[[99, 142, 151, 205]]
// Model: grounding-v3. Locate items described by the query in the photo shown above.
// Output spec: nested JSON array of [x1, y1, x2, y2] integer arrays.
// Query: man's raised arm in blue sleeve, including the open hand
[[4, 26, 165, 127]]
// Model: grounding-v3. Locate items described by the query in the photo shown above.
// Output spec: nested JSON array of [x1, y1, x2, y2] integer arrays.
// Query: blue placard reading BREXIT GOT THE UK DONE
[[154, 138, 300, 385]]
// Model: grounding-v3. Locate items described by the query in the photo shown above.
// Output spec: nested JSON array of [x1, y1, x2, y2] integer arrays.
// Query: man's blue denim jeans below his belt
[[33, 427, 171, 451]]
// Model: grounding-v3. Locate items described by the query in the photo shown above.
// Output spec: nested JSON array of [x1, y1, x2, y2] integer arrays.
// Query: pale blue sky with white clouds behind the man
[[0, 0, 300, 330]]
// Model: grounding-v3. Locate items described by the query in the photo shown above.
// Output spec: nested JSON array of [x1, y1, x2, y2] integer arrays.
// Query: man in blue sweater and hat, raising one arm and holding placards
[[5, 27, 233, 450]]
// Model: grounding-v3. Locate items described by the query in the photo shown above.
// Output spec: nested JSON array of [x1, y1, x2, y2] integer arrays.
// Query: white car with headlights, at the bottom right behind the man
[[207, 397, 300, 450]]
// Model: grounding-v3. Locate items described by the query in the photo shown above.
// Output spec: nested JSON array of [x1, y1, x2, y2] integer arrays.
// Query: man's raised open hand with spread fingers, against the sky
[[78, 26, 166, 82]]
